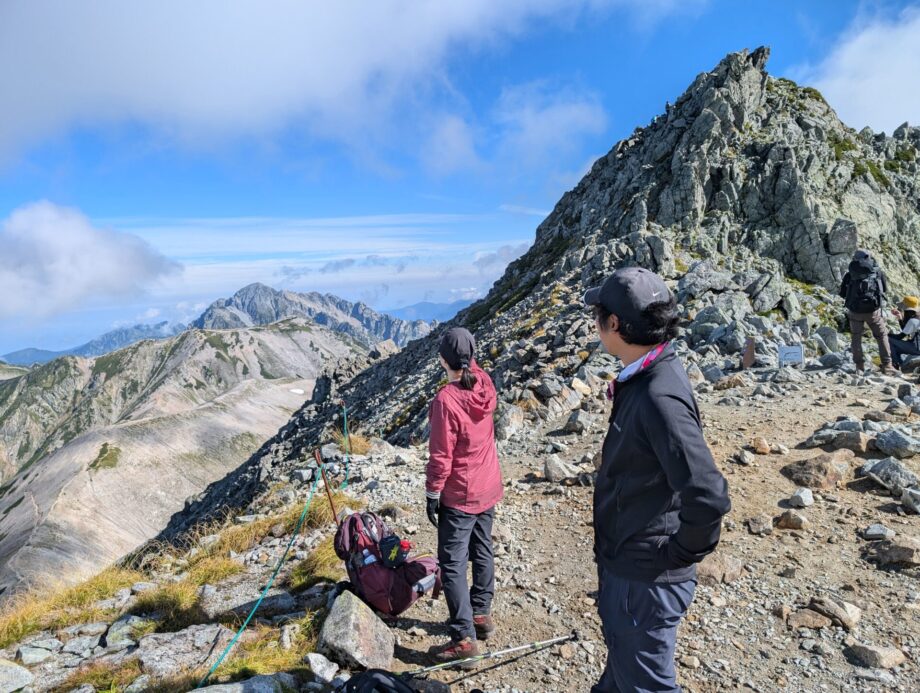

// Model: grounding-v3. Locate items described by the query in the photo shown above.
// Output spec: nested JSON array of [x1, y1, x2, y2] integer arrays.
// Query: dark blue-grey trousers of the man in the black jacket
[[591, 568, 696, 693]]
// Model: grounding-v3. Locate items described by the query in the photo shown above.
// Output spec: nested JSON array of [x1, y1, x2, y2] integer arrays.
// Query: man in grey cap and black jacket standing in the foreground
[[585, 268, 731, 693]]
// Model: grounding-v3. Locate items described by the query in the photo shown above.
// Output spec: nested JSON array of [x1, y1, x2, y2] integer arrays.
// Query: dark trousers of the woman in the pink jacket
[[438, 505, 495, 640]]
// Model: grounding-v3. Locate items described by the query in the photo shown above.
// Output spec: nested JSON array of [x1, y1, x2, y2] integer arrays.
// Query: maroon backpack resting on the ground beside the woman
[[335, 512, 441, 616]]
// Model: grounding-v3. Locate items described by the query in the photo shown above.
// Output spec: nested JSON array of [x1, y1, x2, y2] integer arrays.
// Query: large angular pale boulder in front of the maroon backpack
[[316, 592, 396, 669]]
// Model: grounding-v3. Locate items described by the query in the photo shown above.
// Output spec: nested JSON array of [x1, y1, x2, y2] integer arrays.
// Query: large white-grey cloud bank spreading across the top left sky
[[0, 0, 688, 161]]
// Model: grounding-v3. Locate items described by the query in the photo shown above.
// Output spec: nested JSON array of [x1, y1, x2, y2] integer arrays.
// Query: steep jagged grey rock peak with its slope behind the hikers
[[155, 48, 920, 539]]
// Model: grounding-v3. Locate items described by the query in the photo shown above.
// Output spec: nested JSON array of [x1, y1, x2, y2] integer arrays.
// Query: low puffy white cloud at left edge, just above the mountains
[[0, 202, 181, 318]]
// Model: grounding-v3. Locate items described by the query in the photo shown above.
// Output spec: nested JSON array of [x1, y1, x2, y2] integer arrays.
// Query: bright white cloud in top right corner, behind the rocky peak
[[792, 8, 920, 134]]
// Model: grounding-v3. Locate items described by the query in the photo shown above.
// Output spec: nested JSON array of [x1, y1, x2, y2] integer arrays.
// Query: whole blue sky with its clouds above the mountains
[[0, 0, 920, 354]]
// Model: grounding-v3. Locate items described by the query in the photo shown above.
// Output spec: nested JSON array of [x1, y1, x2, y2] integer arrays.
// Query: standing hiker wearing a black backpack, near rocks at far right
[[840, 250, 894, 375]]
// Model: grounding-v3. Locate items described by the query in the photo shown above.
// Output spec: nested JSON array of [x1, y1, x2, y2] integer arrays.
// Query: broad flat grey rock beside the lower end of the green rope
[[136, 624, 233, 678]]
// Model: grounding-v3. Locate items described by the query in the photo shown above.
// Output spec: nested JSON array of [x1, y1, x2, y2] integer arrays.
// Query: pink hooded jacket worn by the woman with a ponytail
[[425, 361, 504, 515]]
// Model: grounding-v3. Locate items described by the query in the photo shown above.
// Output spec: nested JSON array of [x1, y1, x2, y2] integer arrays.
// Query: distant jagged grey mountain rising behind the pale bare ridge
[[192, 283, 431, 346]]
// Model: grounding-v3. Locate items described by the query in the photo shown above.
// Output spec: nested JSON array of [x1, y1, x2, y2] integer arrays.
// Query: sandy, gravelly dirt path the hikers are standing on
[[366, 375, 920, 692]]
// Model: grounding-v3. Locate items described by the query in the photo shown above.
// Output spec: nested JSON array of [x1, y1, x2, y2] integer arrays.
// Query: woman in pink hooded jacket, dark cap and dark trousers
[[425, 327, 503, 664]]
